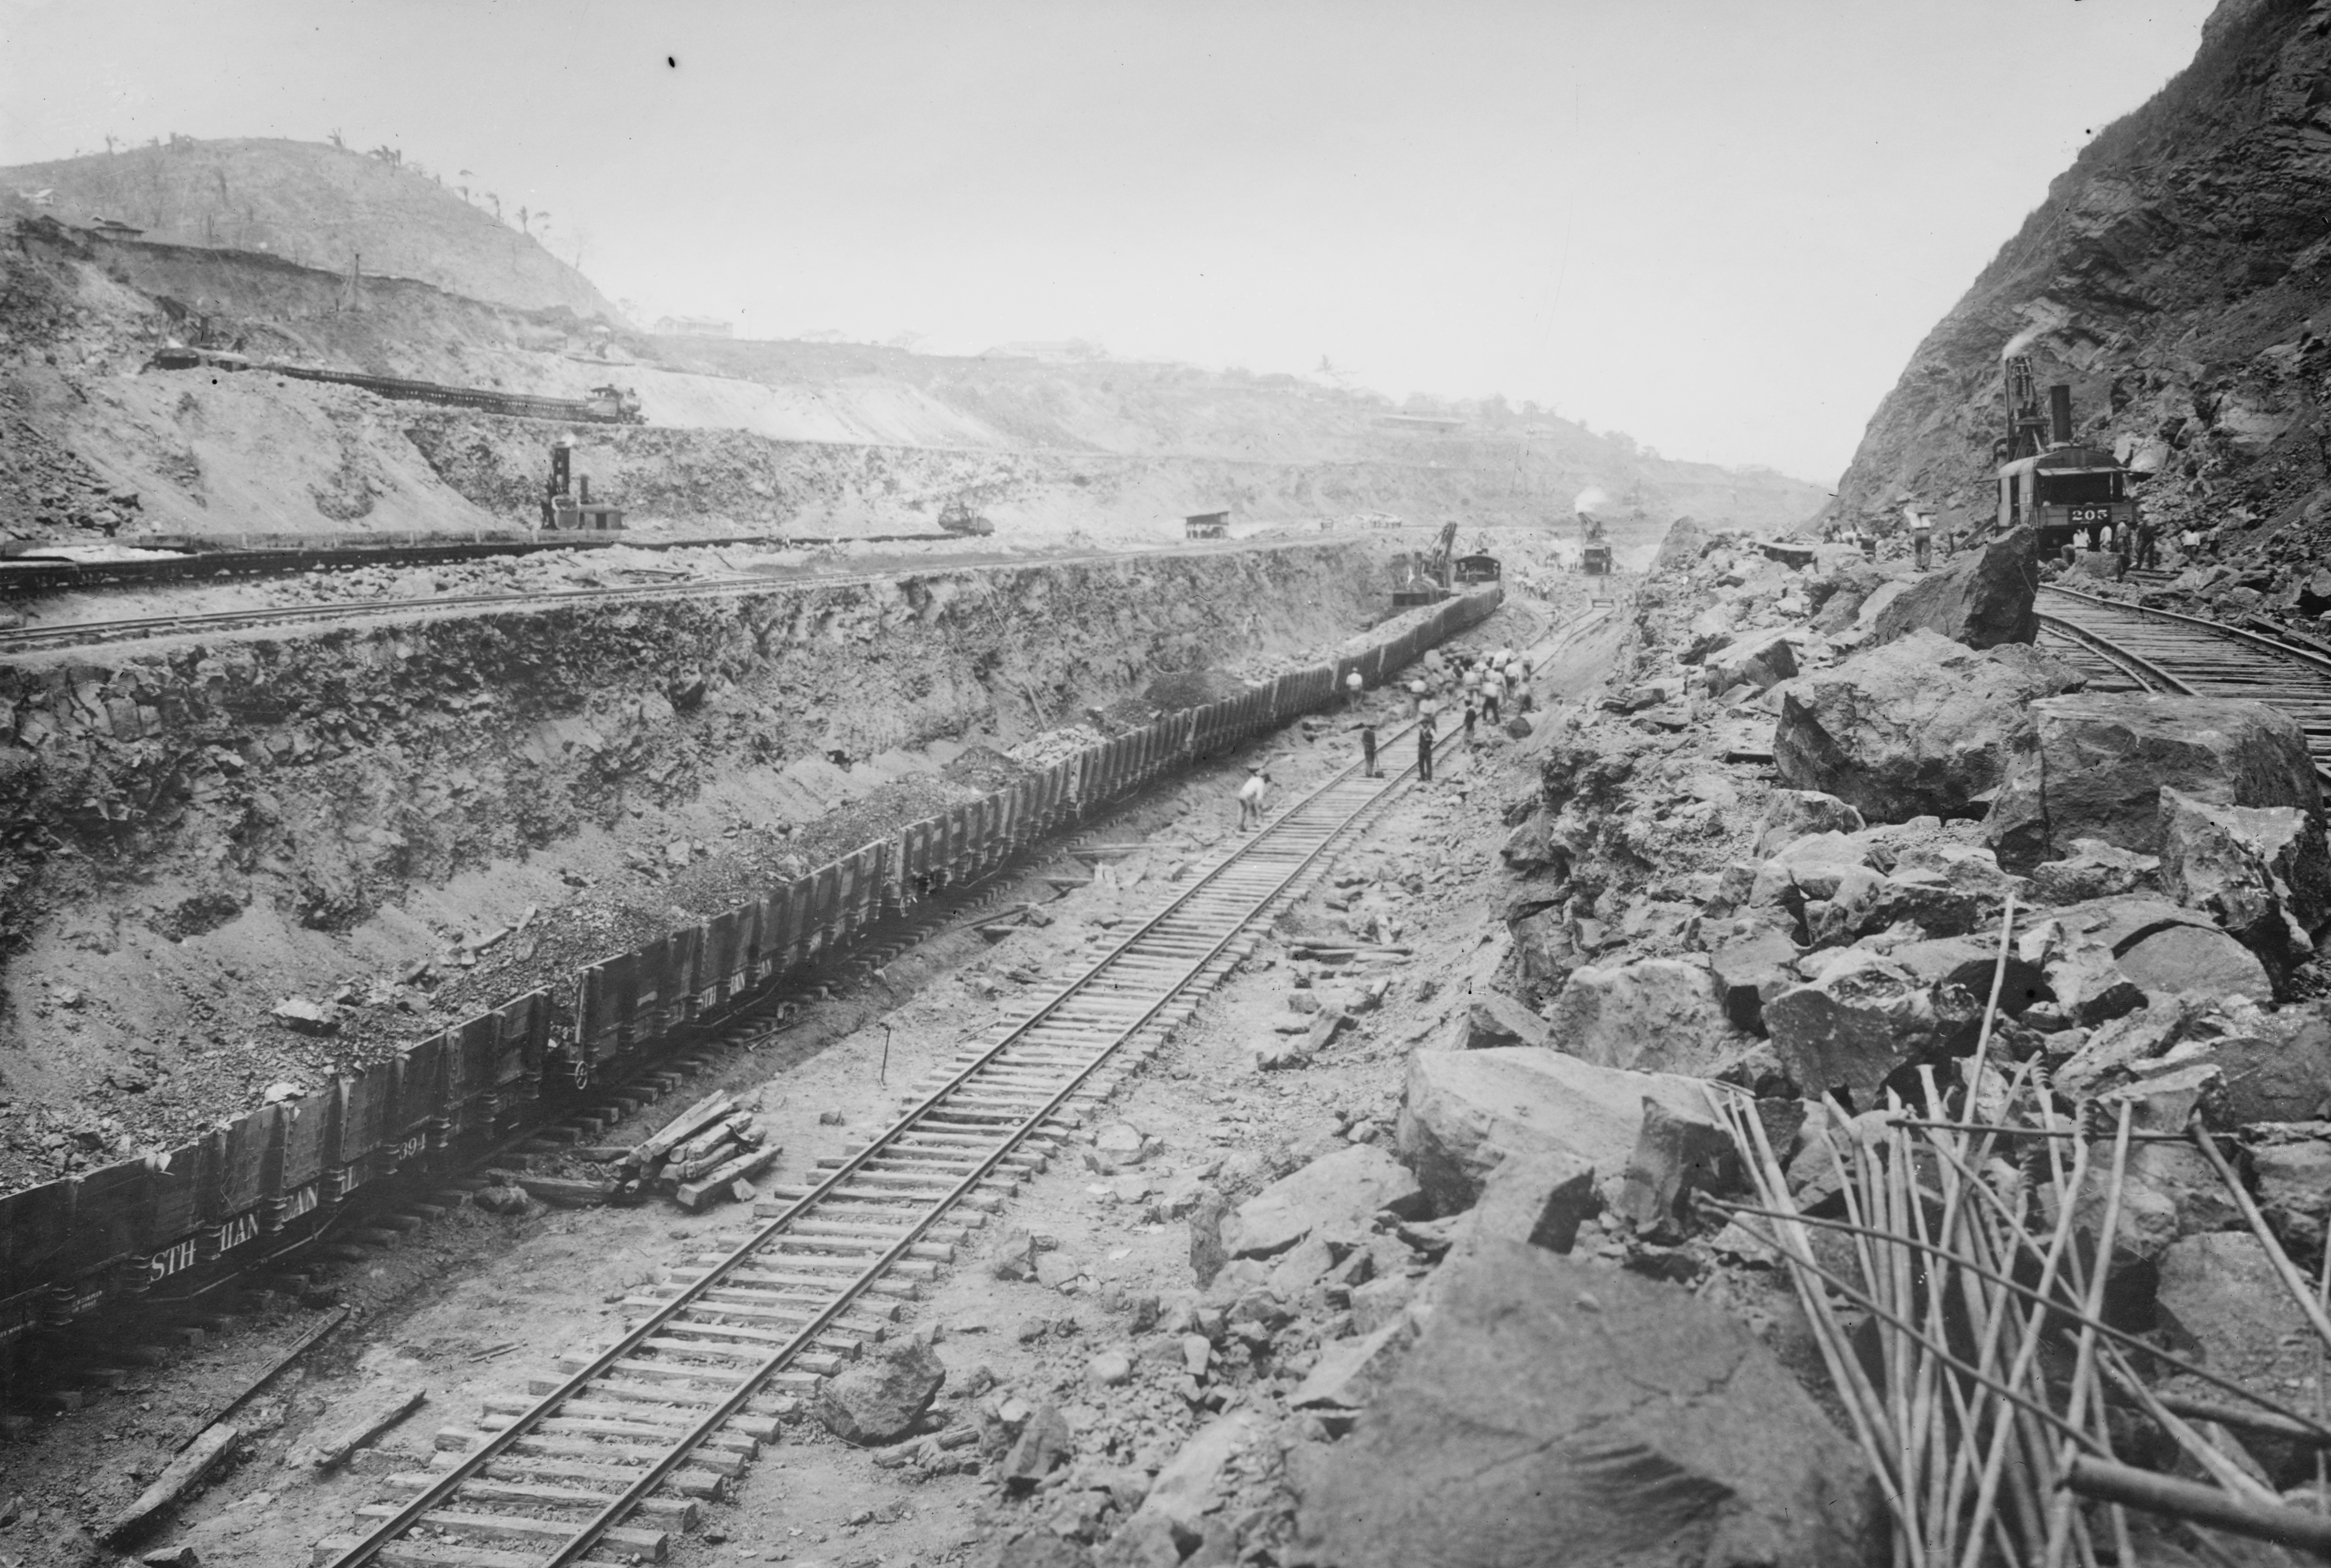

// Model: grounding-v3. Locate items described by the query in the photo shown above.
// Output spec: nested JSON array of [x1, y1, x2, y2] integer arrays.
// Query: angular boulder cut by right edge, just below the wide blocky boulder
[[2161, 785, 2331, 974]]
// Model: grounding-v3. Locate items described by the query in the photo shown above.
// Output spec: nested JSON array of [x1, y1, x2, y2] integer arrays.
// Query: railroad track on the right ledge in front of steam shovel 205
[[2039, 585, 2331, 781]]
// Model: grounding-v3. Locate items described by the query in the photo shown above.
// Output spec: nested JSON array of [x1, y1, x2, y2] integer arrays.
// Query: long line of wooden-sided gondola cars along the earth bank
[[0, 589, 1501, 1344]]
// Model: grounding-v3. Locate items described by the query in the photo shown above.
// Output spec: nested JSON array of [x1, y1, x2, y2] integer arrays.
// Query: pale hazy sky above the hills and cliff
[[0, 0, 2210, 482]]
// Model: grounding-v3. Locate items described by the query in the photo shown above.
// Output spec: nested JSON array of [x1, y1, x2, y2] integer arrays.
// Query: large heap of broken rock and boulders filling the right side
[[927, 536, 2331, 1566]]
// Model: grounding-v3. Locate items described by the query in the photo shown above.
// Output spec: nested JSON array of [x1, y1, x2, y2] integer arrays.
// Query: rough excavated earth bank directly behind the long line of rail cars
[[0, 531, 1384, 1188]]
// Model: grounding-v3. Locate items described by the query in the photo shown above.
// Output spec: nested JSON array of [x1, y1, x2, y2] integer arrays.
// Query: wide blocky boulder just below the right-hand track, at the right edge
[[1988, 692, 2322, 871]]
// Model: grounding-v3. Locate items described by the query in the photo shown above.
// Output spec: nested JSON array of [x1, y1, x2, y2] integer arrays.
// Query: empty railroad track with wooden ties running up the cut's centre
[[315, 613, 1604, 1568]]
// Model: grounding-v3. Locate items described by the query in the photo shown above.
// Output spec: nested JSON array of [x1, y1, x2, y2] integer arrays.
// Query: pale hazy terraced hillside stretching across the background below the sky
[[0, 140, 1820, 543]]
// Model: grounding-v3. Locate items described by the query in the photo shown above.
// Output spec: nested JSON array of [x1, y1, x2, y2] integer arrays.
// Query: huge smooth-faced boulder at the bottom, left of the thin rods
[[1294, 1244, 1881, 1568]]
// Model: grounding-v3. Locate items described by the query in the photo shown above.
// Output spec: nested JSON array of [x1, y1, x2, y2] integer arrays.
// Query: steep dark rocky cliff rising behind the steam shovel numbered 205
[[1837, 0, 2331, 557]]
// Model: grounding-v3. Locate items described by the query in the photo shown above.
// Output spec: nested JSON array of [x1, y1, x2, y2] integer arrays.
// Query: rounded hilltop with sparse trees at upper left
[[0, 138, 615, 319]]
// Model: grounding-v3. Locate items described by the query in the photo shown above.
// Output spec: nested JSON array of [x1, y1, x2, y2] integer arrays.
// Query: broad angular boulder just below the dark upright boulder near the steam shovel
[[1772, 629, 2079, 822]]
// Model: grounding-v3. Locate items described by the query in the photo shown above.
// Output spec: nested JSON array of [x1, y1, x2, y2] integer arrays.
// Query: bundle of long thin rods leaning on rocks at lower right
[[1711, 909, 2331, 1568]]
